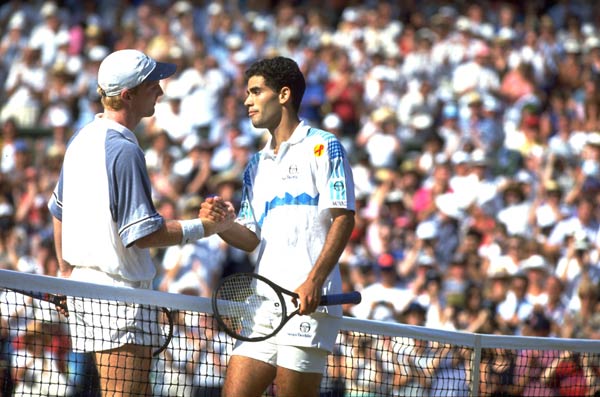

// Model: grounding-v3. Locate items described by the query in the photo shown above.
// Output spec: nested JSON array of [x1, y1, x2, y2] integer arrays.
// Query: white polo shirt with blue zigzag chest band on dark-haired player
[[237, 122, 355, 346]]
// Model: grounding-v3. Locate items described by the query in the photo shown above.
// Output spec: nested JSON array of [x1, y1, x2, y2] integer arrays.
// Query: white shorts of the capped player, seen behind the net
[[67, 267, 161, 352]]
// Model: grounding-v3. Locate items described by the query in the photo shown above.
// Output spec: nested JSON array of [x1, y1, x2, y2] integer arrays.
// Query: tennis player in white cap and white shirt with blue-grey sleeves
[[48, 50, 235, 396]]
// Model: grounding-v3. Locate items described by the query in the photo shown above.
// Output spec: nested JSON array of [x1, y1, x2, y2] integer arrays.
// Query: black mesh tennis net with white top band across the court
[[0, 270, 600, 397]]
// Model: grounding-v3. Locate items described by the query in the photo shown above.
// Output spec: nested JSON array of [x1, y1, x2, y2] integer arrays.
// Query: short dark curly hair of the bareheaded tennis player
[[245, 56, 306, 111]]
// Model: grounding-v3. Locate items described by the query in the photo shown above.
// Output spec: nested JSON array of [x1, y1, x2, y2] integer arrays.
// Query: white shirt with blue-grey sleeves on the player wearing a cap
[[48, 116, 164, 282]]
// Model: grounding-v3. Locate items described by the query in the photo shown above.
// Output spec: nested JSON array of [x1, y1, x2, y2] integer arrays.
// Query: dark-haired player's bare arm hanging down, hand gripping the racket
[[295, 208, 354, 314]]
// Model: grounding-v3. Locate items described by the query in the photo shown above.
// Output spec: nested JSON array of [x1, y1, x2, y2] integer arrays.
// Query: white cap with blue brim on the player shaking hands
[[98, 50, 177, 96]]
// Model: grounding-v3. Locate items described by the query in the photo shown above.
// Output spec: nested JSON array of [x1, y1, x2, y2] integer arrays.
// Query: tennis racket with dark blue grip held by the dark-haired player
[[212, 273, 361, 342]]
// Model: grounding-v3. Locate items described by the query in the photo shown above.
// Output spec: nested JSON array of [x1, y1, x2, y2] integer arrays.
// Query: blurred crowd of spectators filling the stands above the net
[[0, 0, 600, 350]]
